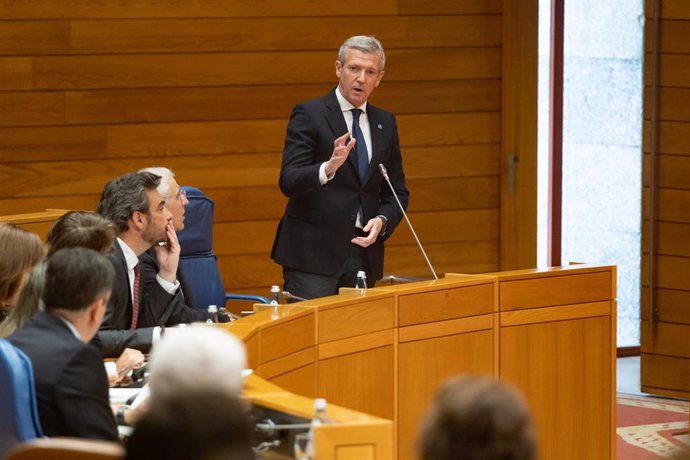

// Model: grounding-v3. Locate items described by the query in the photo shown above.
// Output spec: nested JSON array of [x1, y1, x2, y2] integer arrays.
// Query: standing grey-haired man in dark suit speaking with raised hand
[[271, 36, 409, 299]]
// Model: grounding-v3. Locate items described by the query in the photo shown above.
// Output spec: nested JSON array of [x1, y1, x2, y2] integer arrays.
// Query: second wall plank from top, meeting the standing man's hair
[[67, 15, 501, 57]]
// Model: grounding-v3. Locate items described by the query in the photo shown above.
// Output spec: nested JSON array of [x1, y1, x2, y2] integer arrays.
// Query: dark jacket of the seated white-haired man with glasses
[[139, 248, 207, 326]]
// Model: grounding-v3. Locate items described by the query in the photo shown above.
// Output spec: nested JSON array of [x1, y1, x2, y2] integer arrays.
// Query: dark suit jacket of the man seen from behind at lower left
[[8, 311, 118, 441]]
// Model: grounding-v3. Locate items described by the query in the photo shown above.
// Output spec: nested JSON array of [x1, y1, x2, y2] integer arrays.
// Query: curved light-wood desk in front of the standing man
[[223, 265, 616, 460]]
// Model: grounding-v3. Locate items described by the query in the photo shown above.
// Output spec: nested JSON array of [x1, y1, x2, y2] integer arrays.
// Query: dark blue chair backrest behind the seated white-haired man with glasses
[[177, 186, 225, 310]]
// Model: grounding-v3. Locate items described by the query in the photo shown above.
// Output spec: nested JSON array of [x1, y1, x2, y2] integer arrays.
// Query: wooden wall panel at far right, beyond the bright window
[[640, 0, 690, 398]]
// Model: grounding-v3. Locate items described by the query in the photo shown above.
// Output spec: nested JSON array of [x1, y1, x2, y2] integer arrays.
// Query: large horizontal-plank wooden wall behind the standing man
[[0, 0, 504, 306]]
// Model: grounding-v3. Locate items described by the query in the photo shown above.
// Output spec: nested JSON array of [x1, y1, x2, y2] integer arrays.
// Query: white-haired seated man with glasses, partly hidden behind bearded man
[[139, 167, 206, 326]]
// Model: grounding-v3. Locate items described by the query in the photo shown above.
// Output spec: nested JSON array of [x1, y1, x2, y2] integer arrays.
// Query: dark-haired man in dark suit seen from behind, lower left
[[8, 248, 118, 441]]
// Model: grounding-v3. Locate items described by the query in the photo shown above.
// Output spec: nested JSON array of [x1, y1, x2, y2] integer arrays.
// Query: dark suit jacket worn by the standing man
[[271, 89, 409, 279]]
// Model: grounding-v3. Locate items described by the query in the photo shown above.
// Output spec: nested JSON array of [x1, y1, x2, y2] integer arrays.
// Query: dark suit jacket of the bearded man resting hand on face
[[94, 241, 173, 357]]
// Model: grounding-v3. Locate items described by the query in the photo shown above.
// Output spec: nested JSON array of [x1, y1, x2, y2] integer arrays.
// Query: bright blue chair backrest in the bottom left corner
[[0, 339, 43, 458]]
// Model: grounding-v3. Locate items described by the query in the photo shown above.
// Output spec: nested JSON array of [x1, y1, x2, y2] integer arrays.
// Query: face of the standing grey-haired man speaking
[[335, 48, 383, 107]]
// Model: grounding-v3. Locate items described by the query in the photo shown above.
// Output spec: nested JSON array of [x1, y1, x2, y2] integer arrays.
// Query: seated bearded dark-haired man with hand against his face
[[96, 173, 180, 357]]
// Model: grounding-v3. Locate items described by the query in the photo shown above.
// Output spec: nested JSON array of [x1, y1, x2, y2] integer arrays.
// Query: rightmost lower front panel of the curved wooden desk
[[500, 317, 615, 459]]
